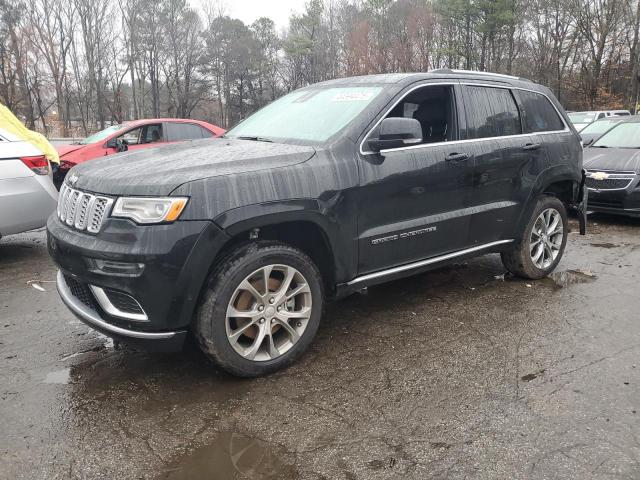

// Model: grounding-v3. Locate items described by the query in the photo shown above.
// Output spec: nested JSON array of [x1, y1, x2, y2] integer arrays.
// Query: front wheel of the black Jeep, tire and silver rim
[[193, 241, 324, 377]]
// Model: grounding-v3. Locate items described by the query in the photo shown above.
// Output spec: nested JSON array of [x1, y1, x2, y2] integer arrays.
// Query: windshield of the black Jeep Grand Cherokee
[[225, 87, 382, 142]]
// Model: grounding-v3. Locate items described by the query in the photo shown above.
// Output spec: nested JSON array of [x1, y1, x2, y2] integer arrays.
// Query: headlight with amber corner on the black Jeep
[[111, 197, 189, 224]]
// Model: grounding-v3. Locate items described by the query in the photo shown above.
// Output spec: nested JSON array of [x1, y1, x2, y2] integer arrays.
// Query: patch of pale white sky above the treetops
[[219, 0, 305, 30]]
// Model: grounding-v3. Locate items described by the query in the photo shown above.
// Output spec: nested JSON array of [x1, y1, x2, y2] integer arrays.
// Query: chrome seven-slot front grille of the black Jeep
[[58, 184, 113, 233]]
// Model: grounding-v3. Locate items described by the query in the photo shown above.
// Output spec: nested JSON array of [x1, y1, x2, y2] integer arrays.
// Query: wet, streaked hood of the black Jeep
[[68, 138, 315, 195]]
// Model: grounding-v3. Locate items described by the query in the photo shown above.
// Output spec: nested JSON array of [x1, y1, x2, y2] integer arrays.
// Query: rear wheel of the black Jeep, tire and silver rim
[[501, 195, 569, 280]]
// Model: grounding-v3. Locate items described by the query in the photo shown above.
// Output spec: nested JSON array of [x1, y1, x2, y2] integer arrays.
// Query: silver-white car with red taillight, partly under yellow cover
[[0, 128, 58, 237]]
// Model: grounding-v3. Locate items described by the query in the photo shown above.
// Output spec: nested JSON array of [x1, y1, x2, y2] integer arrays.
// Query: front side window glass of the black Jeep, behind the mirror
[[387, 85, 457, 144]]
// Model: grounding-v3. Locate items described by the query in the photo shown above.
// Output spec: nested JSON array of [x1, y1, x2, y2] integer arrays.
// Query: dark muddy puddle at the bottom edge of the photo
[[158, 432, 297, 480]]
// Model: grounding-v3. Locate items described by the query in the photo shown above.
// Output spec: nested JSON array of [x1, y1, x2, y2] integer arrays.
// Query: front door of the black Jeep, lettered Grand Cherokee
[[357, 84, 473, 275]]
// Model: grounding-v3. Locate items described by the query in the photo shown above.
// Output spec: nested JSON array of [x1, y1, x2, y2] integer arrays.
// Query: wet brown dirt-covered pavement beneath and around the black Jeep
[[0, 216, 640, 480]]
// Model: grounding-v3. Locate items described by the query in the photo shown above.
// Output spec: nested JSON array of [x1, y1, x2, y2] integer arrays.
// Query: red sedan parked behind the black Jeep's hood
[[53, 118, 225, 189]]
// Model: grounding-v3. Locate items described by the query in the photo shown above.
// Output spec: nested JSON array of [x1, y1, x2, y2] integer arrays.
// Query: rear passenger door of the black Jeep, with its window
[[462, 84, 540, 246]]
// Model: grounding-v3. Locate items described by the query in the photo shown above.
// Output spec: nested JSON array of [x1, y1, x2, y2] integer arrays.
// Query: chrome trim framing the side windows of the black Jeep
[[359, 80, 571, 155]]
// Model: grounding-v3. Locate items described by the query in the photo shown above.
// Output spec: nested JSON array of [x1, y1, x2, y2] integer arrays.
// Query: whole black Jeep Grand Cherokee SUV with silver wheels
[[47, 70, 586, 376]]
